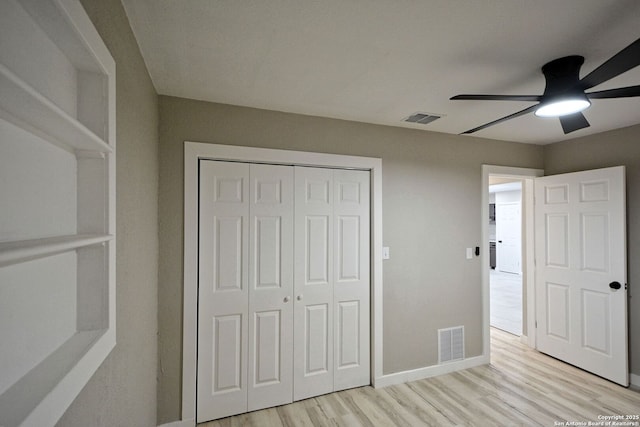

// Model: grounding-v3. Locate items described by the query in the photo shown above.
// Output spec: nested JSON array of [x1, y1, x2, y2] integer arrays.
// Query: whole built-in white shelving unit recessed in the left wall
[[0, 0, 116, 427]]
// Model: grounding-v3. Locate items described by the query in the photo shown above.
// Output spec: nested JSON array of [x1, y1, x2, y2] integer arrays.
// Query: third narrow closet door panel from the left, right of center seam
[[293, 167, 334, 400]]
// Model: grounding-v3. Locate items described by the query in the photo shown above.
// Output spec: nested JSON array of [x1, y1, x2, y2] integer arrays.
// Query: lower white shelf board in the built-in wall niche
[[0, 234, 113, 267]]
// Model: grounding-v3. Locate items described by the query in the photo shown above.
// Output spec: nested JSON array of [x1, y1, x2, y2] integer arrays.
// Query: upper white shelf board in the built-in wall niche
[[0, 64, 113, 153]]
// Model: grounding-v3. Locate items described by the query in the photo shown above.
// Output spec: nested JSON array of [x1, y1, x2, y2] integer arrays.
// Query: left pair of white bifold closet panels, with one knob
[[197, 161, 293, 422]]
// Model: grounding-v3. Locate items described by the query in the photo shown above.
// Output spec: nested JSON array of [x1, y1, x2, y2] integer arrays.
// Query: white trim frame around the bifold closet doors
[[181, 141, 382, 425]]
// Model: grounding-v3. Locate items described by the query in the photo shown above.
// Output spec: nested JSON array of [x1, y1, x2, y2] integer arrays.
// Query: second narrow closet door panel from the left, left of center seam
[[248, 164, 293, 411]]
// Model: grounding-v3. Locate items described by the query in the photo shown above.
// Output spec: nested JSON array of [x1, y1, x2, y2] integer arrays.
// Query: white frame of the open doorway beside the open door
[[480, 165, 544, 360]]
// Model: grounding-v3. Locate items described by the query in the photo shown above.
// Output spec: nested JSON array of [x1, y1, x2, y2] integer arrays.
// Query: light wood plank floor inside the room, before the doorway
[[199, 328, 640, 427]]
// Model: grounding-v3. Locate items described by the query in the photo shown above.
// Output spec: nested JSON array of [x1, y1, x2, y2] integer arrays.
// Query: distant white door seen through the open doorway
[[496, 202, 522, 274]]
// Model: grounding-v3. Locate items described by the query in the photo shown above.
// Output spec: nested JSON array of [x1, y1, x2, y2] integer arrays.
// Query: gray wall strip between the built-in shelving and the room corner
[[58, 0, 158, 427]]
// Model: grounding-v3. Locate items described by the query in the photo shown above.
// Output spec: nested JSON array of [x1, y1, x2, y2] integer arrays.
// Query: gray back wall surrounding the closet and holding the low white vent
[[158, 96, 543, 423]]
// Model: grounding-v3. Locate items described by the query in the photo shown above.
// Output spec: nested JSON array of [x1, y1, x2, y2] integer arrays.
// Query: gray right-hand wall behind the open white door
[[544, 126, 640, 382]]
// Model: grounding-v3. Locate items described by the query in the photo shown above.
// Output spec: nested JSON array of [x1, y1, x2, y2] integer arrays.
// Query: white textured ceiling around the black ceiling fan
[[123, 0, 640, 144]]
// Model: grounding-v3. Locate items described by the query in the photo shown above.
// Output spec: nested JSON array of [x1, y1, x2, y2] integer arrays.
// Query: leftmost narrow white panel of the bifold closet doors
[[196, 161, 249, 422]]
